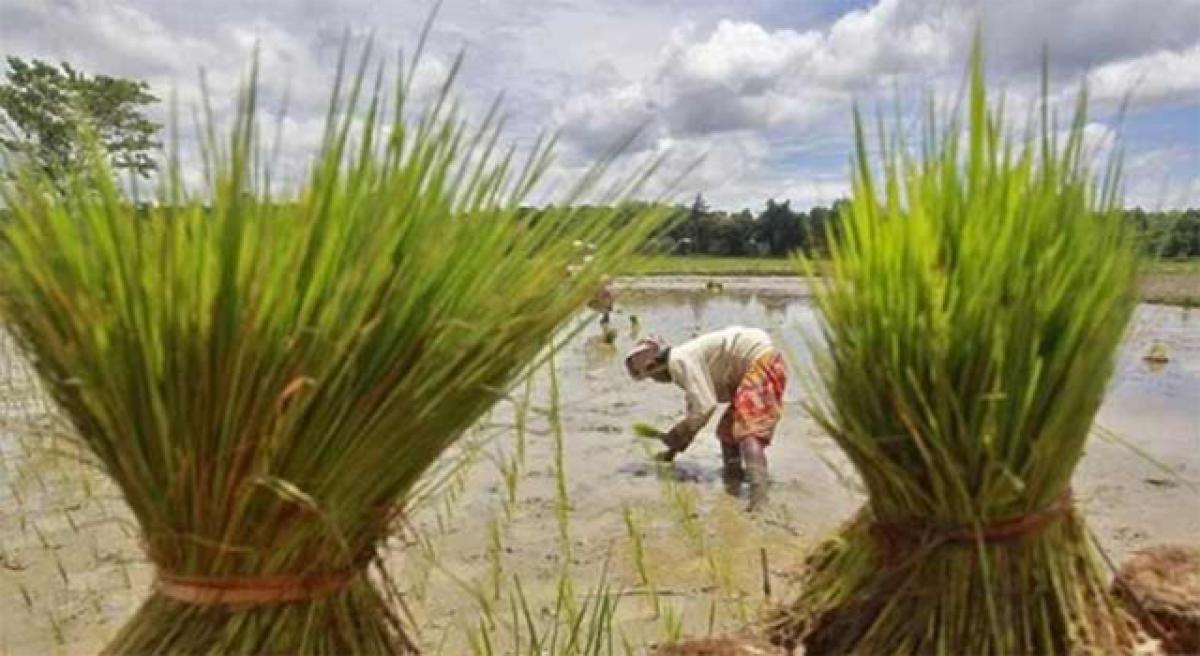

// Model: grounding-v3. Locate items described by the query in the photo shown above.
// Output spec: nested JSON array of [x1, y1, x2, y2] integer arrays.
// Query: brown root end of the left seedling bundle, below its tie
[[104, 576, 418, 655]]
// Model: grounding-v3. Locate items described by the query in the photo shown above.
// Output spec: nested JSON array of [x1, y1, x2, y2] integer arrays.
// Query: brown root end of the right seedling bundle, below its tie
[[768, 510, 1139, 655]]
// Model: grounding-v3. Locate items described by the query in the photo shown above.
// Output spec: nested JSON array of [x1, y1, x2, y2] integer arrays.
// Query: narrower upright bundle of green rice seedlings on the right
[[772, 42, 1138, 654]]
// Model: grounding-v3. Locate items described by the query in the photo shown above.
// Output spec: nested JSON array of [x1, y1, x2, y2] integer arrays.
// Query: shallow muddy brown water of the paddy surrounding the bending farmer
[[0, 277, 1200, 655]]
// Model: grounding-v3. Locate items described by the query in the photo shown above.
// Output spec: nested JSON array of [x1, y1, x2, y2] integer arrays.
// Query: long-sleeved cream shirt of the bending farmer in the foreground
[[667, 326, 774, 438]]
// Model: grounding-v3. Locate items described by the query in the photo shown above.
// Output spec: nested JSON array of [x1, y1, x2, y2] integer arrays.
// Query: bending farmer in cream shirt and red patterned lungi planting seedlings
[[625, 326, 787, 510]]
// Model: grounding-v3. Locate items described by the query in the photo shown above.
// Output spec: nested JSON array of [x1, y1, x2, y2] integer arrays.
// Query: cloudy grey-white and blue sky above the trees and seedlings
[[0, 0, 1200, 209]]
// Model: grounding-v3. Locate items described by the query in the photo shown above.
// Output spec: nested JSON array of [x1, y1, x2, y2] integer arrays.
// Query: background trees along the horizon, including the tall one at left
[[0, 56, 1200, 258]]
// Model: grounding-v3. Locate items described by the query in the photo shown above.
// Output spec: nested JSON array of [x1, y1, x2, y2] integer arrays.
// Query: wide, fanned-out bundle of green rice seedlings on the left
[[0, 39, 664, 654]]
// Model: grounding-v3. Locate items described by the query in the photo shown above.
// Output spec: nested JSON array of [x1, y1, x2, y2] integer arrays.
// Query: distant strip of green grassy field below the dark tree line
[[629, 255, 1200, 307]]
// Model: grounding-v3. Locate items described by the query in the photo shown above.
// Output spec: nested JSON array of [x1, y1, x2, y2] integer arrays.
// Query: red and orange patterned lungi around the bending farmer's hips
[[716, 350, 787, 446]]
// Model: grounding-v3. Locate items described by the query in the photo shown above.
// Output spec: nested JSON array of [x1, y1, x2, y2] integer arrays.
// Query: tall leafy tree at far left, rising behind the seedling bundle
[[0, 56, 161, 180]]
